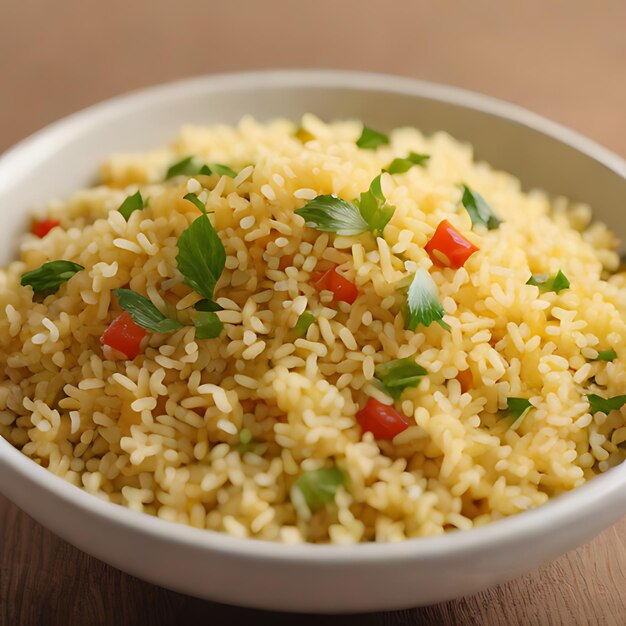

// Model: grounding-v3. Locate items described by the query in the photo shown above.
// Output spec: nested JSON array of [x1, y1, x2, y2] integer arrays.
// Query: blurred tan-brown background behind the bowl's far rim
[[0, 0, 626, 154]]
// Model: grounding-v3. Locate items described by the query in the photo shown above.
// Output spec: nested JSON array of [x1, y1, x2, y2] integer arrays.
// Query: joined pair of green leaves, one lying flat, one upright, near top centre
[[296, 174, 395, 236]]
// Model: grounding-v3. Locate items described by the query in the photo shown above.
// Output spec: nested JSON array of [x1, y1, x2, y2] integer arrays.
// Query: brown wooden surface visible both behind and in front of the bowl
[[0, 0, 626, 626]]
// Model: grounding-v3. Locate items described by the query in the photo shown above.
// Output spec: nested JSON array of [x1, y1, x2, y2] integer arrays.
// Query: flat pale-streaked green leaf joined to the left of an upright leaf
[[295, 195, 369, 235]]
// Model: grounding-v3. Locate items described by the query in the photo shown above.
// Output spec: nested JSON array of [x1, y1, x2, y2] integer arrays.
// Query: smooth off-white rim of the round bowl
[[0, 69, 626, 565]]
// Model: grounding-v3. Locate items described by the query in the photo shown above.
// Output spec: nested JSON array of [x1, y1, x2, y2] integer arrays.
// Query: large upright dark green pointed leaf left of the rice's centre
[[176, 214, 226, 300]]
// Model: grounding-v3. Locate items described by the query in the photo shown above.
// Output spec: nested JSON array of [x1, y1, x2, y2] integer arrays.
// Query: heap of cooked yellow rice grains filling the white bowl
[[0, 116, 626, 543]]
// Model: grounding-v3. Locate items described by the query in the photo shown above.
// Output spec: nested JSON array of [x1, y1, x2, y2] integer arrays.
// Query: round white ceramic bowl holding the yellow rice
[[0, 71, 626, 612]]
